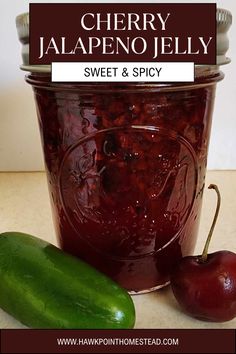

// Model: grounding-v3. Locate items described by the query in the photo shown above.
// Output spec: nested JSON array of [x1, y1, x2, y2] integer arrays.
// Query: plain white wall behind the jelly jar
[[0, 0, 236, 171]]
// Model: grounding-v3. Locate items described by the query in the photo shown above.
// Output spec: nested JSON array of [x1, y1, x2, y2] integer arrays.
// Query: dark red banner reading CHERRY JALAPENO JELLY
[[30, 3, 216, 65]]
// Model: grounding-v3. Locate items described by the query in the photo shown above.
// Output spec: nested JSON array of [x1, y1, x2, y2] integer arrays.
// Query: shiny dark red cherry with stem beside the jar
[[171, 185, 236, 322]]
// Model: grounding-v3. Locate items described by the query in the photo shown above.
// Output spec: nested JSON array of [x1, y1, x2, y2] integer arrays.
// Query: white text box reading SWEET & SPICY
[[52, 62, 194, 82]]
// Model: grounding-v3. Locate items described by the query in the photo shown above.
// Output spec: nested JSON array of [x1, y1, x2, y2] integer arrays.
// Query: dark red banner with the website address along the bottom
[[1, 329, 235, 354]]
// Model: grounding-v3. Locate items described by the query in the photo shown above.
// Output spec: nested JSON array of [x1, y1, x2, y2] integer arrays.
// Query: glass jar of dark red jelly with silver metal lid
[[17, 10, 231, 293]]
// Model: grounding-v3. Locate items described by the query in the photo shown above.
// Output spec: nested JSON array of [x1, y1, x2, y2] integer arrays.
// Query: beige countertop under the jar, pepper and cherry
[[0, 171, 236, 329]]
